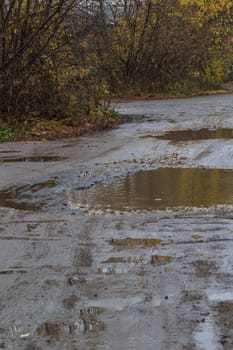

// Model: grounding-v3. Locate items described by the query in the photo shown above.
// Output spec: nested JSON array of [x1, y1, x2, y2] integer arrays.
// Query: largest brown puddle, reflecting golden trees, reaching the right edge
[[72, 168, 233, 210]]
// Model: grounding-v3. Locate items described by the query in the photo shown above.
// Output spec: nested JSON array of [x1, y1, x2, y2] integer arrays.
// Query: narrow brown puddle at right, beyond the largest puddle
[[157, 128, 233, 142]]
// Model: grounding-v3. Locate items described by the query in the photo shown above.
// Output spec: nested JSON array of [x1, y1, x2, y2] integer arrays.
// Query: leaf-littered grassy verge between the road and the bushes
[[0, 87, 233, 142]]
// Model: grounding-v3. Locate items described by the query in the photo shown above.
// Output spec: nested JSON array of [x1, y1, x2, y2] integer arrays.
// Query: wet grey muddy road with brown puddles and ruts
[[0, 94, 233, 350]]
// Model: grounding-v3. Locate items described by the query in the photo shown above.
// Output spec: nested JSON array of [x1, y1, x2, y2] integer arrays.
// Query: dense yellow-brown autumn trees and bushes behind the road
[[0, 0, 233, 120]]
